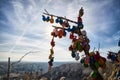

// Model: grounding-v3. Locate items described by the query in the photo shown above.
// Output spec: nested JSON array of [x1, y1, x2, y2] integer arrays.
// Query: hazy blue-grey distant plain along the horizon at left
[[0, 62, 74, 76]]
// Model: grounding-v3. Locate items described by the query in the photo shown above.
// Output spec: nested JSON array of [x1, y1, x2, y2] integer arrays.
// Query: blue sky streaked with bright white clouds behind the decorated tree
[[0, 0, 120, 62]]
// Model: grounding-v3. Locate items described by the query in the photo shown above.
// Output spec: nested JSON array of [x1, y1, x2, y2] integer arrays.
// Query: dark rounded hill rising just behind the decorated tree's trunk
[[42, 63, 91, 80]]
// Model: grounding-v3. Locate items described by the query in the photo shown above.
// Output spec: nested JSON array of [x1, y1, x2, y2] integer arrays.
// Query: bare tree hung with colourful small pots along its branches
[[42, 7, 106, 80]]
